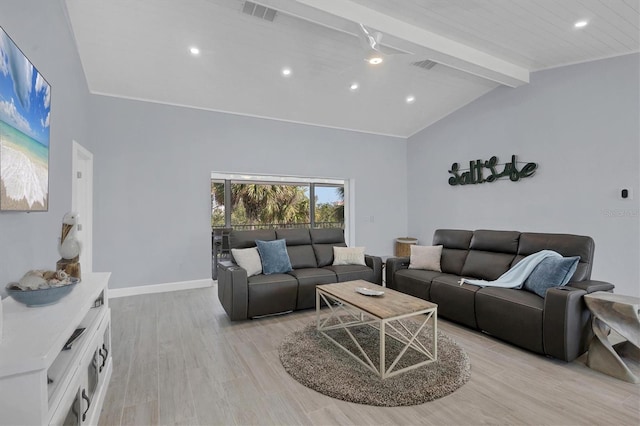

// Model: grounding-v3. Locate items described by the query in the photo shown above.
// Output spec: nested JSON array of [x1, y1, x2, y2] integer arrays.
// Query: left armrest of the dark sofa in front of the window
[[218, 261, 249, 321]]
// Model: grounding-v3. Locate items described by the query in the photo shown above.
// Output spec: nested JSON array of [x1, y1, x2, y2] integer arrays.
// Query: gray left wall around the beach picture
[[0, 0, 91, 289]]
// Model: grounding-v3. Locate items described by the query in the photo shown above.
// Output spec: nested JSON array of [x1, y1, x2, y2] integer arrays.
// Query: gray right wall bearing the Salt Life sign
[[407, 54, 640, 296]]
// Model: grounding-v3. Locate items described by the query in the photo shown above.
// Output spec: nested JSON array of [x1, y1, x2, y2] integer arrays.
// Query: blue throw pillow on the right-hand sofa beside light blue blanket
[[523, 256, 580, 297]]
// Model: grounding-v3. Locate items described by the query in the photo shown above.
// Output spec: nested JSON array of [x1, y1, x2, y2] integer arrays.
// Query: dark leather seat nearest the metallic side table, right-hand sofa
[[476, 287, 544, 354]]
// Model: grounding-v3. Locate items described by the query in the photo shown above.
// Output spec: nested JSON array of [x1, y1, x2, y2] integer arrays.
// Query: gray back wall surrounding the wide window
[[90, 96, 407, 288]]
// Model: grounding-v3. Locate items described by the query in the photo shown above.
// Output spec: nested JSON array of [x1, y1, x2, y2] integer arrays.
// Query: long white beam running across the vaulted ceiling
[[292, 0, 529, 87]]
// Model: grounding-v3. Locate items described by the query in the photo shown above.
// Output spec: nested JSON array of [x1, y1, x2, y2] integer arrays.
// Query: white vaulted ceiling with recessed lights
[[64, 0, 640, 137]]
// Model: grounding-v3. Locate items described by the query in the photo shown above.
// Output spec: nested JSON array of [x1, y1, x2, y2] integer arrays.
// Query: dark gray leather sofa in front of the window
[[218, 228, 382, 320]]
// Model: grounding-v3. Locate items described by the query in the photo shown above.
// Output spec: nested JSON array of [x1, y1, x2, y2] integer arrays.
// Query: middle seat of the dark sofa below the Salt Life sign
[[430, 274, 480, 328]]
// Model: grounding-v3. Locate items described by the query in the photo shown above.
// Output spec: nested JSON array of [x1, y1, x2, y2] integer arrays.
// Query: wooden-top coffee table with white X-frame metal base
[[316, 280, 438, 379]]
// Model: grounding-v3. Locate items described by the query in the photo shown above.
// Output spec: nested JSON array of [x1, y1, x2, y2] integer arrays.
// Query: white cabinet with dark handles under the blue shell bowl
[[0, 273, 113, 425]]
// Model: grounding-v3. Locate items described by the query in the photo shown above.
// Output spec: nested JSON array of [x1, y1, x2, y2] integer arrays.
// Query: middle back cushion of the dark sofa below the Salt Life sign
[[461, 230, 520, 281]]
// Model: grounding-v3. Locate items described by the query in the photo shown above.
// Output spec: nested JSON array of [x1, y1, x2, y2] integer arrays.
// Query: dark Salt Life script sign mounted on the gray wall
[[449, 155, 538, 186]]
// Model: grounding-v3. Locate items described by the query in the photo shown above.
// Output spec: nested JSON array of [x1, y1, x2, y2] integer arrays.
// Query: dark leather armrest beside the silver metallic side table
[[542, 283, 593, 362]]
